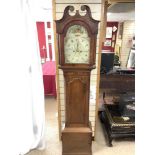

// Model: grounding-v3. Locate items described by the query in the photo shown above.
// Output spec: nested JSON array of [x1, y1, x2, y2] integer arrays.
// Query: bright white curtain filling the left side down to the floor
[[0, 0, 45, 155]]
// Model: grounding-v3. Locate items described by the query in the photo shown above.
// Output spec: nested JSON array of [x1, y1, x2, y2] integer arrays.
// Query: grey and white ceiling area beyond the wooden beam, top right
[[107, 3, 135, 22]]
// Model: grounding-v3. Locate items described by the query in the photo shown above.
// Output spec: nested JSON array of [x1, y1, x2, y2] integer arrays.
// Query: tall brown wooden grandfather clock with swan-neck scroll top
[[56, 5, 99, 155]]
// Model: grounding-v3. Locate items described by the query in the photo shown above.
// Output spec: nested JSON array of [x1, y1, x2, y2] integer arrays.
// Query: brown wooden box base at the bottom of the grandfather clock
[[62, 127, 92, 155]]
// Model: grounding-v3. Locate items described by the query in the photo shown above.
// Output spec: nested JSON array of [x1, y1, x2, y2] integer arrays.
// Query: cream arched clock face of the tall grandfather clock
[[64, 25, 90, 64]]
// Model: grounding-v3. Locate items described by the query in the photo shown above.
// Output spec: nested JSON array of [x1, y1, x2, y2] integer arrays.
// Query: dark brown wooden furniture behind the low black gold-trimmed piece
[[100, 70, 135, 97]]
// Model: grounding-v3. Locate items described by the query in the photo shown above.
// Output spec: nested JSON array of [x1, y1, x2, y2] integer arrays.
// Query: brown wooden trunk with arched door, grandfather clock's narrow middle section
[[64, 70, 90, 127]]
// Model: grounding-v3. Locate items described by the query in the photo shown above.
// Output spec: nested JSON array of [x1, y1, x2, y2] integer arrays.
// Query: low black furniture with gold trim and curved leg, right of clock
[[99, 93, 135, 146]]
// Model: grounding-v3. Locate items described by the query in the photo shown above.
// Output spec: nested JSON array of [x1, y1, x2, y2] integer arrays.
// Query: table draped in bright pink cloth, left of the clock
[[42, 61, 56, 97]]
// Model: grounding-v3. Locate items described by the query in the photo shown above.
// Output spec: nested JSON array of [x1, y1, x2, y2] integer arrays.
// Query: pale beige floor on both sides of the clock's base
[[27, 97, 135, 155]]
